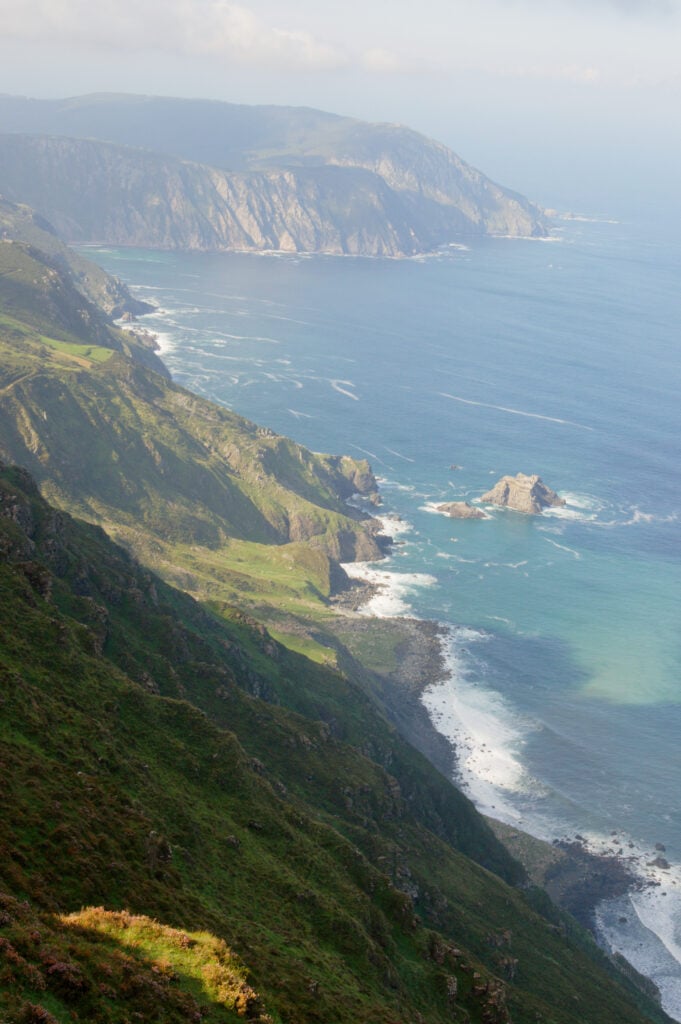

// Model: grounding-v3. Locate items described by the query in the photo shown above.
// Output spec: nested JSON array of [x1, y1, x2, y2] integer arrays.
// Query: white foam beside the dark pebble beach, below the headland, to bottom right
[[421, 620, 681, 1021]]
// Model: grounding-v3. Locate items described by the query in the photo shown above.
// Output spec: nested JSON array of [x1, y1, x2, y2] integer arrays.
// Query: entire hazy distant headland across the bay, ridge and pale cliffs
[[0, 95, 549, 256]]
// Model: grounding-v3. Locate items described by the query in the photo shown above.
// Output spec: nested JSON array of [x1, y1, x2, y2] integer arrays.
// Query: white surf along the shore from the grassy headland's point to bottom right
[[343, 516, 681, 1021]]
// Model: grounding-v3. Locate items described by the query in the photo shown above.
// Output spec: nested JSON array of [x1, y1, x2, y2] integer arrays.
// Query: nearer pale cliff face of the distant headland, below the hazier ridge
[[0, 135, 544, 256]]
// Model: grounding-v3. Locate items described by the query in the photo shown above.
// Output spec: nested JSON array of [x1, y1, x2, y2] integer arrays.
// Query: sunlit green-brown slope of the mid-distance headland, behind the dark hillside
[[0, 243, 378, 630]]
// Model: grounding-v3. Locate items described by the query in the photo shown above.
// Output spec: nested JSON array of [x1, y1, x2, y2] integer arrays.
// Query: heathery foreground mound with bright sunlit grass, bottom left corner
[[0, 893, 272, 1024]]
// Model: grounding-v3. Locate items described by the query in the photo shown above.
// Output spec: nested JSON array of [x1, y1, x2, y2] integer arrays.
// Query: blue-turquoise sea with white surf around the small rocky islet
[[87, 211, 681, 1020]]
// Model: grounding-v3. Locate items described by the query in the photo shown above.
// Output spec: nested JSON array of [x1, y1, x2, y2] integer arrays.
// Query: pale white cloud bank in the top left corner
[[0, 0, 349, 71]]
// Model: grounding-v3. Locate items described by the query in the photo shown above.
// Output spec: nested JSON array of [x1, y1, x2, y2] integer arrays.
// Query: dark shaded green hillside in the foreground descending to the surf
[[0, 470, 664, 1024]]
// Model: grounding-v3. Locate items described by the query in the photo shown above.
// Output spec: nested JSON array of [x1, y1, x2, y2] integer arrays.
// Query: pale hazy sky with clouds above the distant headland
[[0, 0, 681, 215]]
